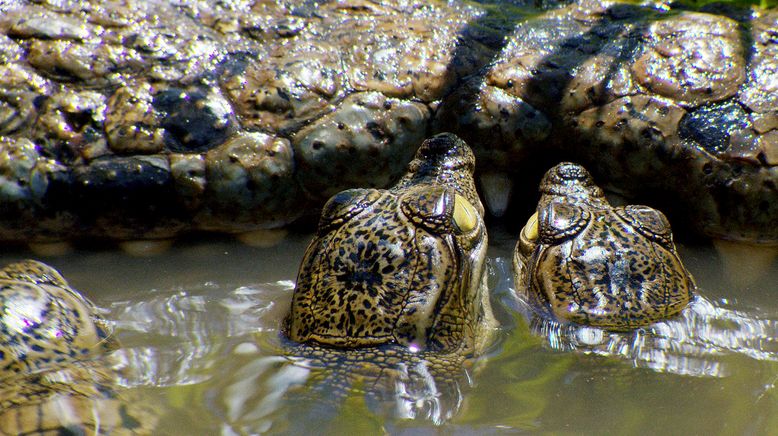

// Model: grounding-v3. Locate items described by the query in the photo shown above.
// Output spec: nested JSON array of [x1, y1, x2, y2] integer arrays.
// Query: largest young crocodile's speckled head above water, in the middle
[[286, 134, 492, 351]]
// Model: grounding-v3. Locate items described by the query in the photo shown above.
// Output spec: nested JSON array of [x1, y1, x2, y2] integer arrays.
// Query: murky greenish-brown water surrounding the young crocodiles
[[2, 232, 778, 435]]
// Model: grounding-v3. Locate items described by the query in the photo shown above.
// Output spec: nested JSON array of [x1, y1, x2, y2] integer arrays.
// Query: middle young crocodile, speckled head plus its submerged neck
[[284, 133, 496, 419]]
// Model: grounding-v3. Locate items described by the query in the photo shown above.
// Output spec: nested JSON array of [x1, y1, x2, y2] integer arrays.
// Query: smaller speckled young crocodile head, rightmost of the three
[[513, 163, 695, 330]]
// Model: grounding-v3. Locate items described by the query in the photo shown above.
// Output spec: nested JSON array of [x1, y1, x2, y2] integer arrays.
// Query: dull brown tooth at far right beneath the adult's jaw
[[713, 239, 778, 288]]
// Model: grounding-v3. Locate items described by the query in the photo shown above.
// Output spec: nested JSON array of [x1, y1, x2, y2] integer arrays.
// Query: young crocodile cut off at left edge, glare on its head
[[0, 261, 156, 435]]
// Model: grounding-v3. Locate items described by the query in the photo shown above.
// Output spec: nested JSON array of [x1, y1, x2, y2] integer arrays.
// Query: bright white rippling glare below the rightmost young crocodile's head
[[527, 297, 778, 377]]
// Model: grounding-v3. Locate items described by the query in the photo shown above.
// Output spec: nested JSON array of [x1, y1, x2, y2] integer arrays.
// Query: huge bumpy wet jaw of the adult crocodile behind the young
[[0, 0, 778, 244]]
